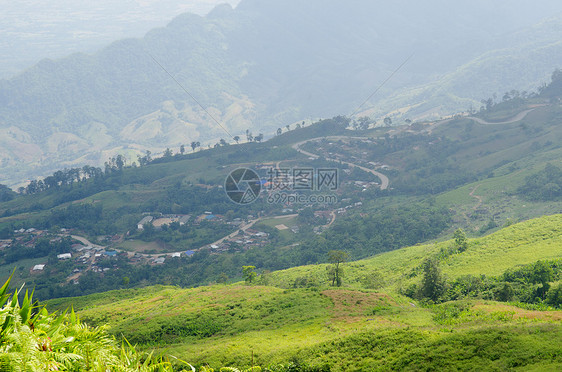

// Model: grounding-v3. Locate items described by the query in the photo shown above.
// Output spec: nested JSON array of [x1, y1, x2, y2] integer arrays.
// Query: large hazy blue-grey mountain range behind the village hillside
[[0, 0, 561, 184]]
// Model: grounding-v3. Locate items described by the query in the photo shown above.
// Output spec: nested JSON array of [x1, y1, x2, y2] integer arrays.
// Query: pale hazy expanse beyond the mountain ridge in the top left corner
[[0, 0, 240, 78]]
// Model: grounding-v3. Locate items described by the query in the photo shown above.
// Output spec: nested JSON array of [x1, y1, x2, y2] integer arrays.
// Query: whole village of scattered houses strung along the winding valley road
[[0, 155, 380, 284]]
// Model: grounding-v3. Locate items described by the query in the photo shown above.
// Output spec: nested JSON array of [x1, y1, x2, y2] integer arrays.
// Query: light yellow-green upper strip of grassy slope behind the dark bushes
[[264, 215, 562, 288]]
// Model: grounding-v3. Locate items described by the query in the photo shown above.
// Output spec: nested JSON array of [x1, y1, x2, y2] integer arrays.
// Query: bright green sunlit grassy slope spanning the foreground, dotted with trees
[[44, 215, 562, 371]]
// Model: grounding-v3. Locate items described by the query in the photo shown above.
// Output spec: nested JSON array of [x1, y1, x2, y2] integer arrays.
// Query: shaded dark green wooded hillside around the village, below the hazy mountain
[[0, 91, 562, 299]]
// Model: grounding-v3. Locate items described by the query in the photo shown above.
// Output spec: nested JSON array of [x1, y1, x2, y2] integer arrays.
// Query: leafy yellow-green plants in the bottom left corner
[[0, 274, 195, 371]]
